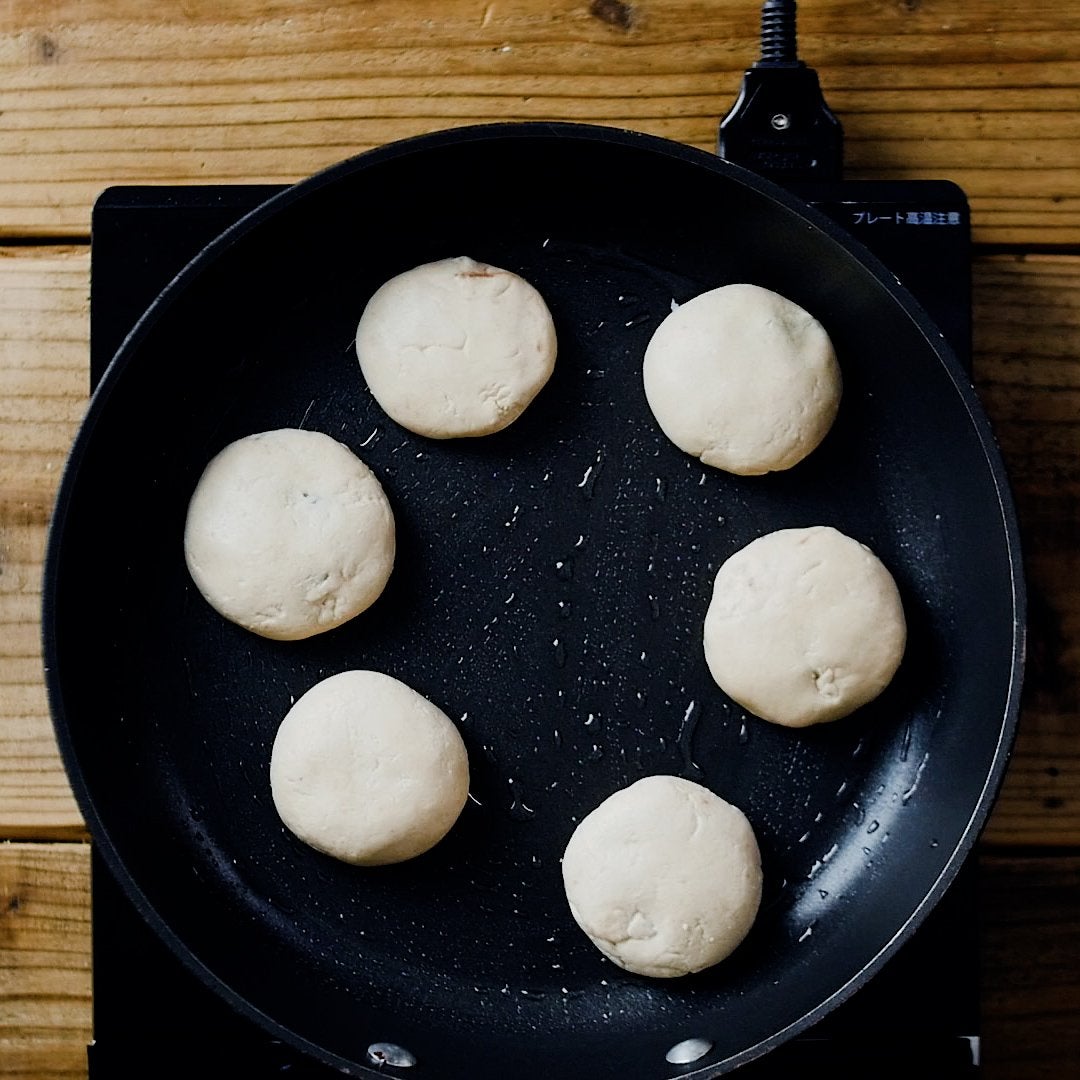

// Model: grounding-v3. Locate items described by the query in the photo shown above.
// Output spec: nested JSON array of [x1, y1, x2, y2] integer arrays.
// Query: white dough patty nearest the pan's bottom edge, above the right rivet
[[563, 777, 761, 978]]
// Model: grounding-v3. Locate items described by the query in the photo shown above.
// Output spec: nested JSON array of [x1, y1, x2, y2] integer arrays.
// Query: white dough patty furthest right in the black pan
[[704, 526, 906, 728]]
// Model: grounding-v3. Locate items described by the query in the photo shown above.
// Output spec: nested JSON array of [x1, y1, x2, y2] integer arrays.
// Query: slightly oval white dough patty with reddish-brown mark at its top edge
[[356, 256, 555, 438]]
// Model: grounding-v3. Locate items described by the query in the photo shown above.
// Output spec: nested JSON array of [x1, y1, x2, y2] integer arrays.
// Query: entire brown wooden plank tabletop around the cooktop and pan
[[0, 0, 1080, 1080]]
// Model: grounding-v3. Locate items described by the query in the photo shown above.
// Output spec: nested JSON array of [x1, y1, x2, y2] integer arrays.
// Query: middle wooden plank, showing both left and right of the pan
[[0, 248, 1080, 845]]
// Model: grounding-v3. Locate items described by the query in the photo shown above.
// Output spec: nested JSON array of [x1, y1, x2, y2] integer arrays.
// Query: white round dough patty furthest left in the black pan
[[184, 428, 394, 640]]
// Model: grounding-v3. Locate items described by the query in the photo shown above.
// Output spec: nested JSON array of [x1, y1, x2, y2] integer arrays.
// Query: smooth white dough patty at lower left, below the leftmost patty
[[270, 671, 469, 866]]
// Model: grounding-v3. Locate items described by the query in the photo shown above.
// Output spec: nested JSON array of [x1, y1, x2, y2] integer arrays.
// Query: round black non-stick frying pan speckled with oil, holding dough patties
[[44, 124, 1023, 1080]]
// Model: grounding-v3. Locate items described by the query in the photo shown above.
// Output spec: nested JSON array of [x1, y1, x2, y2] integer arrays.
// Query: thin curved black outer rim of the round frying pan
[[42, 122, 1026, 1080]]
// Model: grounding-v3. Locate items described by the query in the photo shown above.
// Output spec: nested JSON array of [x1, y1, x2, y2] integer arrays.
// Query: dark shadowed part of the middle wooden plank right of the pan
[[974, 256, 1080, 845]]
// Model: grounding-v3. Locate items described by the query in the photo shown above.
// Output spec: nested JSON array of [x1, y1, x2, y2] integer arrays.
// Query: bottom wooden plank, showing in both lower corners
[[0, 843, 1080, 1080]]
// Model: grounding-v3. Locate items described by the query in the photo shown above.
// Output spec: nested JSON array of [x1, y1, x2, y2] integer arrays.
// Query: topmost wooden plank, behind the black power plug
[[0, 0, 1080, 244]]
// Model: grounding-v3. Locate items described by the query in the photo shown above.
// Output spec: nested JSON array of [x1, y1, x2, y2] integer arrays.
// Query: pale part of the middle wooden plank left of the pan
[[0, 247, 89, 839]]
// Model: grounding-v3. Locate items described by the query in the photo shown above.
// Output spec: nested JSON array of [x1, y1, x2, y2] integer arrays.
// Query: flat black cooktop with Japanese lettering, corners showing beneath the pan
[[87, 181, 978, 1080]]
